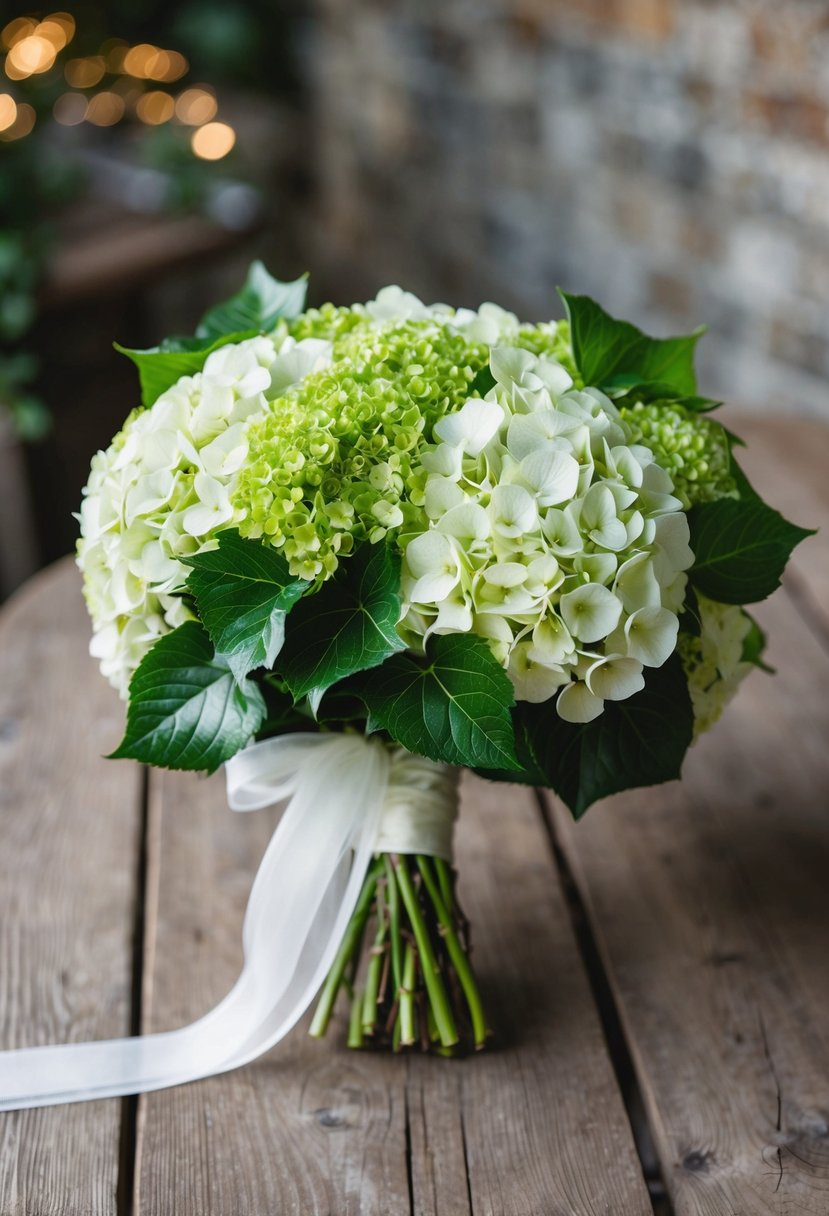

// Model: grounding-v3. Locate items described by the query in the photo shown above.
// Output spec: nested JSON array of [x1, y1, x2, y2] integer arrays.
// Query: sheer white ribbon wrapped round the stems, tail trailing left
[[0, 734, 457, 1110]]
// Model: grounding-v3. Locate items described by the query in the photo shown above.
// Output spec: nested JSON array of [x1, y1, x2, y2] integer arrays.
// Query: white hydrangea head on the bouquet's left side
[[78, 333, 331, 697]]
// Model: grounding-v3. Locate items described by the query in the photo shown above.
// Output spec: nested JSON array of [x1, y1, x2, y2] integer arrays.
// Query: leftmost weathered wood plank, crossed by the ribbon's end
[[0, 562, 141, 1216]]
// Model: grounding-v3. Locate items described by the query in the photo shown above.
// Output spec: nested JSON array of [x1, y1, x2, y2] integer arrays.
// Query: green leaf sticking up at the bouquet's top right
[[559, 291, 705, 396]]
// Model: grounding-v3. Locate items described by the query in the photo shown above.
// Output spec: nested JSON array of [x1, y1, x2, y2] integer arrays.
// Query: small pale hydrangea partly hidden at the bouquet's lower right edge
[[679, 592, 754, 734]]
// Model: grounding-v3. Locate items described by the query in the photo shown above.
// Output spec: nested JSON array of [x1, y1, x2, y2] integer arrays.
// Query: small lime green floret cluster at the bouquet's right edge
[[620, 401, 737, 510]]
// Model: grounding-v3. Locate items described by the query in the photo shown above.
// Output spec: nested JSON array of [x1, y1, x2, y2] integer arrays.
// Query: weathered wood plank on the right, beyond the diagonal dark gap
[[544, 583, 829, 1216]]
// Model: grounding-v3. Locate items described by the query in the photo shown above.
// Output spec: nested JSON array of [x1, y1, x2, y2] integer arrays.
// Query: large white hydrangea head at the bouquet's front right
[[401, 347, 693, 722]]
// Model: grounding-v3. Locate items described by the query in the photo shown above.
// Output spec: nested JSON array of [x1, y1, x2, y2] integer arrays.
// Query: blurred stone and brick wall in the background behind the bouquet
[[295, 0, 829, 415]]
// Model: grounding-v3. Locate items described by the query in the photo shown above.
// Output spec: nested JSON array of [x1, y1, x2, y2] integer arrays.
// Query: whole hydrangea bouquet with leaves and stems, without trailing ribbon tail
[[78, 264, 807, 1053]]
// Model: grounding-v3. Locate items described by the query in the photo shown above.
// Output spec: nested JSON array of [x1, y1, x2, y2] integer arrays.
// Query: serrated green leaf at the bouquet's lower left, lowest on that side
[[109, 620, 265, 772]]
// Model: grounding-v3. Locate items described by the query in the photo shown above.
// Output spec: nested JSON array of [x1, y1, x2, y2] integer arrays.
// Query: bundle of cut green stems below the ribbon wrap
[[310, 854, 489, 1055]]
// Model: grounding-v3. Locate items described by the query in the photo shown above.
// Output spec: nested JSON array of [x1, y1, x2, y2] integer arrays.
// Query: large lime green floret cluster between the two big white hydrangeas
[[233, 310, 489, 579]]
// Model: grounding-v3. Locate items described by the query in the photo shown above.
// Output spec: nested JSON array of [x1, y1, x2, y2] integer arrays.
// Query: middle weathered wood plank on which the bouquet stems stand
[[136, 775, 650, 1216]]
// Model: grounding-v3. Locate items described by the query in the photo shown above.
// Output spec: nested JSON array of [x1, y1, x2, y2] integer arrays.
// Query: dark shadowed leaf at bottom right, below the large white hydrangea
[[504, 654, 694, 818]]
